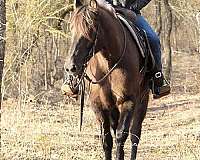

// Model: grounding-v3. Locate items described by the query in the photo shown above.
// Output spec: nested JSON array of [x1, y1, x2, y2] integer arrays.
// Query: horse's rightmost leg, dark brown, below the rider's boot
[[130, 95, 149, 160]]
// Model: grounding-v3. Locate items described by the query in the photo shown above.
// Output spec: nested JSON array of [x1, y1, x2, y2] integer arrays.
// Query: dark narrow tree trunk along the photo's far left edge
[[0, 0, 6, 108]]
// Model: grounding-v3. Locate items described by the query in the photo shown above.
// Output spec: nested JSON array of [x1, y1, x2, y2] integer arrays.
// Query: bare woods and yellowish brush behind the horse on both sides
[[3, 0, 200, 98]]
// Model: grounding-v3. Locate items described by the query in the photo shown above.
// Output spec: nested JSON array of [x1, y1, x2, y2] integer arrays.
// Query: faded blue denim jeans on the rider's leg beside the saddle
[[135, 14, 162, 70]]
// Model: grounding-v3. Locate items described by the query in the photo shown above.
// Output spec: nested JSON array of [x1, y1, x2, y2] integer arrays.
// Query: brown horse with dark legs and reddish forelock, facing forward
[[63, 0, 149, 160]]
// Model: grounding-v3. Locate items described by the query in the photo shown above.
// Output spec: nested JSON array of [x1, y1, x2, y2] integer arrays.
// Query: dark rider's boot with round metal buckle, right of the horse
[[152, 65, 171, 99]]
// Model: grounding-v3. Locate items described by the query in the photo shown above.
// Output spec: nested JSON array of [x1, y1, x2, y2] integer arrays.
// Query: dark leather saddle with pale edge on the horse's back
[[115, 7, 155, 73]]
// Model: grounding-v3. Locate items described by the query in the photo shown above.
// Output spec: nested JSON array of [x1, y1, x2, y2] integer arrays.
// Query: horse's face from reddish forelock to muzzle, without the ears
[[66, 7, 96, 75]]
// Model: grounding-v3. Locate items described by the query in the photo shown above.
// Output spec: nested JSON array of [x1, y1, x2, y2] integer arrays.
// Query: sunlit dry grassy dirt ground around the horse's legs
[[0, 53, 200, 160]]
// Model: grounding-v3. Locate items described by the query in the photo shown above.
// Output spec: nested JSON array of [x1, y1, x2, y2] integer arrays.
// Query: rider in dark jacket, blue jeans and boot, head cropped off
[[104, 0, 170, 98]]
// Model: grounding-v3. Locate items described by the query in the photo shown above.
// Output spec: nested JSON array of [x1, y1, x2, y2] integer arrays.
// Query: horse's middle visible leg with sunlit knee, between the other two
[[116, 100, 134, 160]]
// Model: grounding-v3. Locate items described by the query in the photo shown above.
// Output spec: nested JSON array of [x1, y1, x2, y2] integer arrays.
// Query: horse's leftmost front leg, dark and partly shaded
[[93, 101, 113, 160]]
